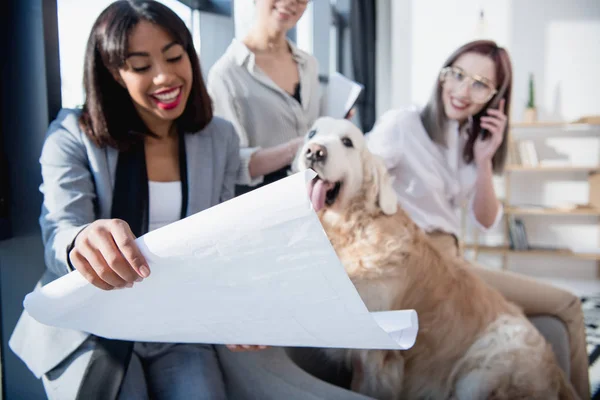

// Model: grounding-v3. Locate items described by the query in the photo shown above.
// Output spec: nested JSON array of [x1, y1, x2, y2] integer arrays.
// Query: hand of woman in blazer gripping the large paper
[[69, 219, 150, 290]]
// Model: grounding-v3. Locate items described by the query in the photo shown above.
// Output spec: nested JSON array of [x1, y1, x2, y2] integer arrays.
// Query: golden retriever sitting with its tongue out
[[294, 118, 577, 400]]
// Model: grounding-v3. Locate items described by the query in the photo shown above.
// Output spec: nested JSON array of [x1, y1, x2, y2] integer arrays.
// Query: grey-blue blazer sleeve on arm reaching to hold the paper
[[39, 111, 96, 276]]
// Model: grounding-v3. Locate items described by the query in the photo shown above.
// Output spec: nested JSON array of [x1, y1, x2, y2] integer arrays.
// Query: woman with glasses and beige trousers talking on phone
[[367, 41, 590, 399]]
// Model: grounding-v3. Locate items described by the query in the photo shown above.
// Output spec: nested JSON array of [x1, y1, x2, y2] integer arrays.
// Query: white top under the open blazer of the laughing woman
[[148, 181, 182, 232]]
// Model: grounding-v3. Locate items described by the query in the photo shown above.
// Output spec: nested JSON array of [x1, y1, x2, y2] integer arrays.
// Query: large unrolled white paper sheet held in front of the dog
[[24, 171, 418, 349]]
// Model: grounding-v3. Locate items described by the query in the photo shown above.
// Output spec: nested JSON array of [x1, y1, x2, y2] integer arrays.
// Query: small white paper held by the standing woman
[[324, 72, 364, 118]]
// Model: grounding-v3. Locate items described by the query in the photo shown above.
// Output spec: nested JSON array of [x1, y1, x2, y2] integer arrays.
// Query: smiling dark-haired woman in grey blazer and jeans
[[10, 0, 239, 399]]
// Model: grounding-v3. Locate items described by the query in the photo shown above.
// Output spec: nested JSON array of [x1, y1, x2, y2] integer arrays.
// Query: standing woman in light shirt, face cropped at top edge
[[208, 0, 321, 195]]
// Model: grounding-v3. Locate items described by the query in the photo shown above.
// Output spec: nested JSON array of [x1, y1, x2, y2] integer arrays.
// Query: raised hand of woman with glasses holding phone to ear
[[473, 99, 508, 167]]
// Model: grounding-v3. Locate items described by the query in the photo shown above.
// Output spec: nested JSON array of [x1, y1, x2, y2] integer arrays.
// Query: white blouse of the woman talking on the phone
[[366, 107, 504, 237]]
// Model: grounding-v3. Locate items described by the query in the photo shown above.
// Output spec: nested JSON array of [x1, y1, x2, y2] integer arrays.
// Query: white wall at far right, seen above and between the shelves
[[508, 0, 600, 282]]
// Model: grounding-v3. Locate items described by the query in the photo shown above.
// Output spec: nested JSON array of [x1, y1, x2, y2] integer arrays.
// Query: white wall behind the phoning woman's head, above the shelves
[[378, 0, 600, 120]]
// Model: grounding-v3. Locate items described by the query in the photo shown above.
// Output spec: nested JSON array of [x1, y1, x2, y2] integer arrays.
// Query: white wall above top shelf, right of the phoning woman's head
[[509, 0, 600, 121]]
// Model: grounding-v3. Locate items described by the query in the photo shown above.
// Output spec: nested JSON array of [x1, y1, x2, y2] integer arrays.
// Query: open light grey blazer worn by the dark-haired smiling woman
[[9, 110, 240, 378]]
